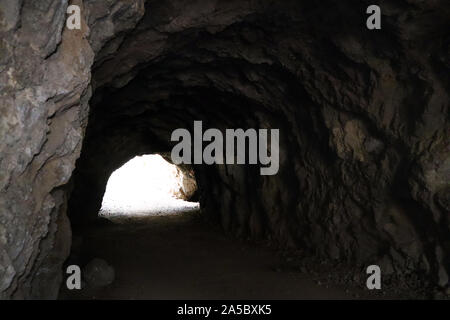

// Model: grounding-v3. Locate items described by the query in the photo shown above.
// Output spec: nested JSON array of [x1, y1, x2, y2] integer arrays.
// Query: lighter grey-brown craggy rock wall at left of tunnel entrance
[[0, 0, 143, 299]]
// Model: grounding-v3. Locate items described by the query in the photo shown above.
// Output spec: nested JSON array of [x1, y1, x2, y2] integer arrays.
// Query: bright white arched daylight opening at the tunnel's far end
[[99, 155, 199, 217]]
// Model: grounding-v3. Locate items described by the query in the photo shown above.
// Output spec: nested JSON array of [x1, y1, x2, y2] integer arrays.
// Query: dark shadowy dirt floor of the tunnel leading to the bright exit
[[60, 212, 376, 299]]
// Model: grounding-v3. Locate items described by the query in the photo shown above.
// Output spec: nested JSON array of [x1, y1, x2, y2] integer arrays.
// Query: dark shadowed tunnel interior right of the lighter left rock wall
[[48, 1, 450, 299]]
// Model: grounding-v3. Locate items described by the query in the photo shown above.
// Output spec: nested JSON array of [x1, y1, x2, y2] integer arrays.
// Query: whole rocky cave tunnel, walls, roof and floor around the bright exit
[[0, 0, 450, 299]]
